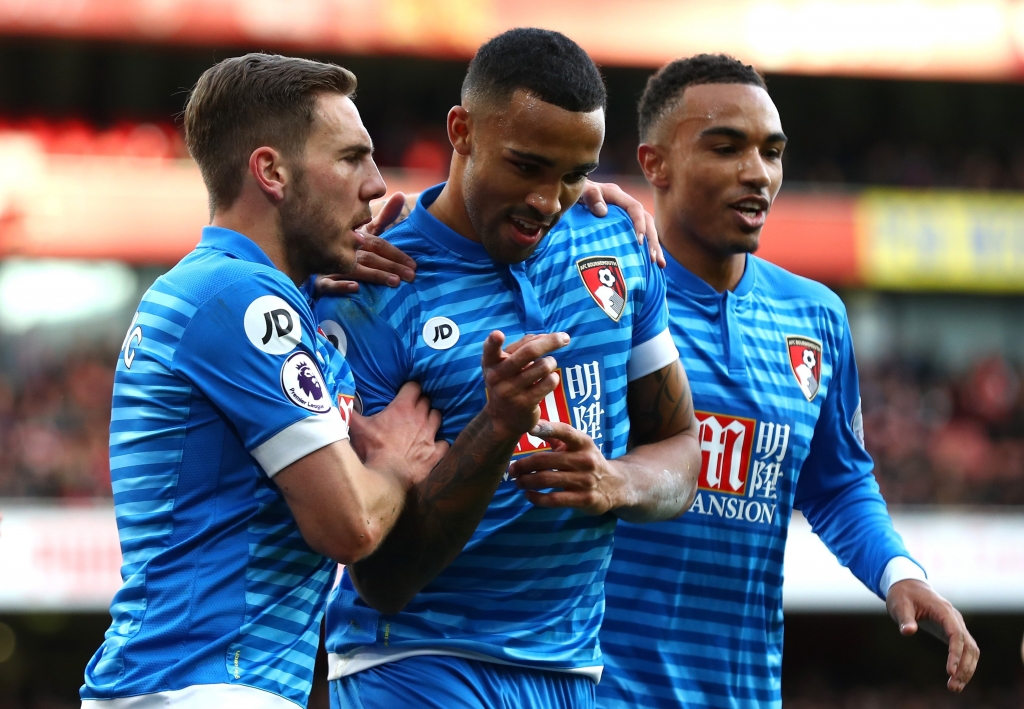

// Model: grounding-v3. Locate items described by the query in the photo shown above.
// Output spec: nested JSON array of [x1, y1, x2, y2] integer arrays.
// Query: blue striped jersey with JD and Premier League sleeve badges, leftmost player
[[81, 226, 354, 707]]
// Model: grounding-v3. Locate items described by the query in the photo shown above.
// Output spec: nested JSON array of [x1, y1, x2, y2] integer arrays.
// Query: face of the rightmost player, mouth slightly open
[[649, 84, 785, 255]]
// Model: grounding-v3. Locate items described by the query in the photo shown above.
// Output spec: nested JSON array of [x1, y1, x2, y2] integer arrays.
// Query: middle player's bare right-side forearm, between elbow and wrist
[[611, 430, 700, 523]]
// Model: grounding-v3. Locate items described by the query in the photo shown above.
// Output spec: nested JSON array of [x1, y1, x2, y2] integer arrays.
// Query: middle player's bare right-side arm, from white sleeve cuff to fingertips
[[509, 360, 700, 523]]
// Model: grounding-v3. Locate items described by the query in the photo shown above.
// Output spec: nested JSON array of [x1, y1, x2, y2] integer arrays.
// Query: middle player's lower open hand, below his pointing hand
[[509, 421, 625, 514]]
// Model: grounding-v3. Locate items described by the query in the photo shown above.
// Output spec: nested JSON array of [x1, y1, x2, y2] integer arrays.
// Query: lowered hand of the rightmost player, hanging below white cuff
[[886, 579, 981, 692]]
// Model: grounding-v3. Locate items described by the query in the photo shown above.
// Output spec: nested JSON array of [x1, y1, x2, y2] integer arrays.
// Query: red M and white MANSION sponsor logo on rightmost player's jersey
[[690, 411, 792, 525]]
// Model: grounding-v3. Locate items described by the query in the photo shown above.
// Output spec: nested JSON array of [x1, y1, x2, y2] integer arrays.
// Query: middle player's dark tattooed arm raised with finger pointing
[[349, 331, 569, 614]]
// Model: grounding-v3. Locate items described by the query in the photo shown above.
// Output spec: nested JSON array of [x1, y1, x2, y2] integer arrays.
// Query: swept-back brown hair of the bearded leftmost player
[[184, 53, 355, 213]]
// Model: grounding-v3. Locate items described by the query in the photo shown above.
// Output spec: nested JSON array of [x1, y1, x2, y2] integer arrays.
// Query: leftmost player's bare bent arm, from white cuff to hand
[[274, 383, 447, 564]]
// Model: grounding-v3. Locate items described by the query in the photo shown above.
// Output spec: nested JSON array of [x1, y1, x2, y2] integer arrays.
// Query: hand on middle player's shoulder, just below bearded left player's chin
[[316, 192, 416, 297]]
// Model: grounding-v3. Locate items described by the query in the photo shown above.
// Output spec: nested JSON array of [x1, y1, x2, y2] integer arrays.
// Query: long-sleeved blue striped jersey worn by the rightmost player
[[598, 256, 907, 709]]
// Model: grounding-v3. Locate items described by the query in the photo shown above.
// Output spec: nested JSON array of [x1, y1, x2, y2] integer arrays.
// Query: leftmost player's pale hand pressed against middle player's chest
[[350, 381, 449, 490]]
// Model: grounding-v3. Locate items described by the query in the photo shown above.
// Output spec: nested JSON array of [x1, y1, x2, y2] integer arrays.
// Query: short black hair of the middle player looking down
[[462, 28, 607, 113]]
